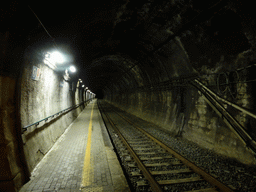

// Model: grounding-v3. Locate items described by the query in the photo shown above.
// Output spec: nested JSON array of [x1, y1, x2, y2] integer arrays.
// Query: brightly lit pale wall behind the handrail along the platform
[[20, 58, 83, 172]]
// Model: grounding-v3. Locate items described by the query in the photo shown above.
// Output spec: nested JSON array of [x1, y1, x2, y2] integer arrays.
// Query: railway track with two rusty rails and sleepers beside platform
[[99, 101, 233, 192]]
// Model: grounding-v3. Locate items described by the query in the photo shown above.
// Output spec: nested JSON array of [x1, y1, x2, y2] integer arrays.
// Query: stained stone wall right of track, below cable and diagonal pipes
[[106, 76, 255, 164]]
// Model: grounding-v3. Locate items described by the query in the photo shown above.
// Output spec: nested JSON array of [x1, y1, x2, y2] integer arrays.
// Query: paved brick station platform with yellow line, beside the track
[[20, 100, 130, 192]]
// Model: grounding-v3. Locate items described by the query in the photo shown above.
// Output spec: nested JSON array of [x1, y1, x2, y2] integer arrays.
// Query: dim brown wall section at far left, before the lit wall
[[0, 76, 25, 191]]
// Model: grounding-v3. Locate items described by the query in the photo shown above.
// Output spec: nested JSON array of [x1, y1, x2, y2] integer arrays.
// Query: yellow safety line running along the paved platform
[[81, 103, 94, 188]]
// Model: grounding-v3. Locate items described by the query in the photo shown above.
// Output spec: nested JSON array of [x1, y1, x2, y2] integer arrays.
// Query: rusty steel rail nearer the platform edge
[[98, 103, 163, 192]]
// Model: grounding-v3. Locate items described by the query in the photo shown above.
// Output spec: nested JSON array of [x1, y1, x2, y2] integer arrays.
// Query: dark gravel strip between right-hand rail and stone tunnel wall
[[99, 101, 256, 192]]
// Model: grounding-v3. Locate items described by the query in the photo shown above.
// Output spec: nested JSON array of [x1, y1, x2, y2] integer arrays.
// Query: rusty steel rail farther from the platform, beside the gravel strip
[[112, 107, 233, 192]]
